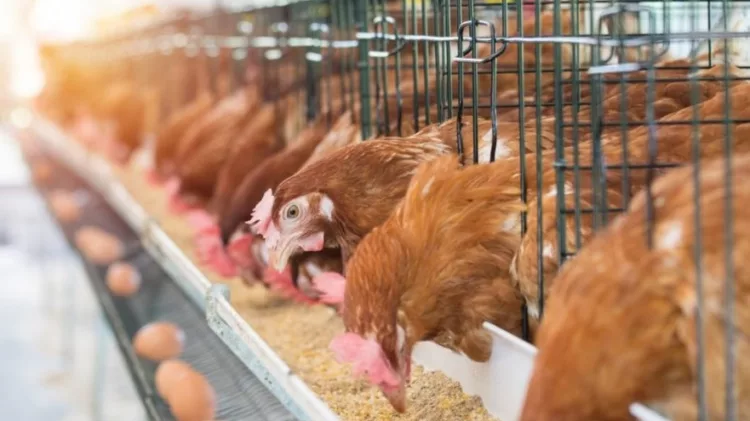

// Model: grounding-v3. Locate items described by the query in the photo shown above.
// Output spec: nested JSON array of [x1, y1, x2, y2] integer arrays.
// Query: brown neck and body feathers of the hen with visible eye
[[272, 137, 450, 259]]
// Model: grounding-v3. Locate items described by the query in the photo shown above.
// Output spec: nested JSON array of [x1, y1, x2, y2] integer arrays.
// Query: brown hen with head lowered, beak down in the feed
[[331, 156, 522, 411]]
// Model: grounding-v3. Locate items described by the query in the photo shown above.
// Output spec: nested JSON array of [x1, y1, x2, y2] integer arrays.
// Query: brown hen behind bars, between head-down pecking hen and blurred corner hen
[[511, 84, 750, 316]]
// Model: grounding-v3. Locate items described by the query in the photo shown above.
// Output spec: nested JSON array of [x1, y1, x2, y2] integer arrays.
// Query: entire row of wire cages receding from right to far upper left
[[39, 0, 750, 418]]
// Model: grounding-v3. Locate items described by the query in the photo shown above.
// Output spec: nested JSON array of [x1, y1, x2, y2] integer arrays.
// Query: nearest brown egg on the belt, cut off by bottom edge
[[167, 372, 216, 421]]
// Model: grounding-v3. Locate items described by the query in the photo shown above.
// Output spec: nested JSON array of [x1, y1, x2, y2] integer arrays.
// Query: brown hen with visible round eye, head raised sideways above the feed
[[253, 115, 536, 268]]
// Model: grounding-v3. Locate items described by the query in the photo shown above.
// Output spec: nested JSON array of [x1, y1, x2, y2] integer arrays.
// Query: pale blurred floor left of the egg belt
[[0, 129, 145, 421]]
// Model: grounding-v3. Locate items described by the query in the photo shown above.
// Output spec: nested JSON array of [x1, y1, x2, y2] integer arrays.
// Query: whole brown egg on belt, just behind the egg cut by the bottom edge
[[133, 322, 185, 361]]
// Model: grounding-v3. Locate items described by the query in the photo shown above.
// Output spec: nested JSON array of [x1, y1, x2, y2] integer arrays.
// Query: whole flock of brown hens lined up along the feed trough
[[30, 5, 750, 421]]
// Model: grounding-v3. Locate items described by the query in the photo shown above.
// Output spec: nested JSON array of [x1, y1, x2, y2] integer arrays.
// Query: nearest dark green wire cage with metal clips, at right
[[356, 0, 749, 419]]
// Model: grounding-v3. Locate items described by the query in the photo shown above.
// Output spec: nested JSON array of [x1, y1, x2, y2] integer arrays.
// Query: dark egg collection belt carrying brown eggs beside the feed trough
[[20, 128, 295, 421]]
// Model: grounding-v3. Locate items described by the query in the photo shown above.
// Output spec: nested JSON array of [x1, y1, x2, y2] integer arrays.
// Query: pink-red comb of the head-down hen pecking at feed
[[329, 332, 401, 387]]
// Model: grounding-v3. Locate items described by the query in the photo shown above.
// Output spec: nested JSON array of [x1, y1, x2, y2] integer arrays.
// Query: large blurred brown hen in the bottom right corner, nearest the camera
[[521, 154, 750, 421]]
